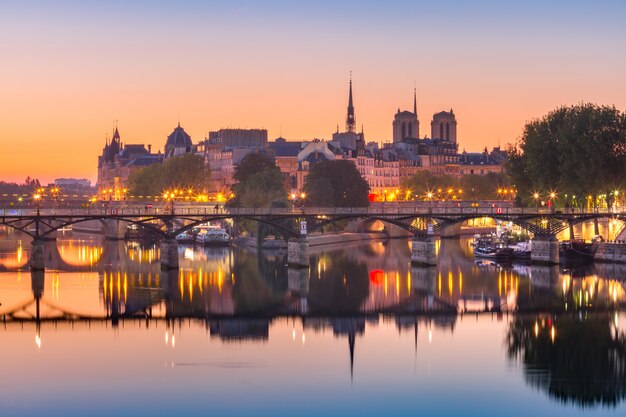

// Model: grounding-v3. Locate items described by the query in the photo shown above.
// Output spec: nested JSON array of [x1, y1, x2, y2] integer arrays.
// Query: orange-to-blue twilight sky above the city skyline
[[0, 0, 626, 183]]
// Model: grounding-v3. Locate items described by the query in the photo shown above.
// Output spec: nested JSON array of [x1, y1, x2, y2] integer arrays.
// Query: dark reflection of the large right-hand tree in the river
[[506, 313, 626, 406]]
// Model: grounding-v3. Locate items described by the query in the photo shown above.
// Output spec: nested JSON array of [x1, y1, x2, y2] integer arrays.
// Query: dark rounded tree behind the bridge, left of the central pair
[[228, 154, 287, 207]]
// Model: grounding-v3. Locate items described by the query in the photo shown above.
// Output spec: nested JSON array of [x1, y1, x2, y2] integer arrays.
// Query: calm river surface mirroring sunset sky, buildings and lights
[[0, 231, 626, 416]]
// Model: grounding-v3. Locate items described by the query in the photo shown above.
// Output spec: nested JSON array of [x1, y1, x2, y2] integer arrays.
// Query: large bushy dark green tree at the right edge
[[507, 104, 626, 202]]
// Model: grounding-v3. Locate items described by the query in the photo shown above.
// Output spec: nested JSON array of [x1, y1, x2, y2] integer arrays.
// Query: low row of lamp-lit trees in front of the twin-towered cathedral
[[400, 171, 510, 200]]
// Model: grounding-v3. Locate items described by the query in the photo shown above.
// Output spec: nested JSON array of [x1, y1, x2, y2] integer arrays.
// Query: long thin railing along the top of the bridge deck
[[0, 206, 626, 218]]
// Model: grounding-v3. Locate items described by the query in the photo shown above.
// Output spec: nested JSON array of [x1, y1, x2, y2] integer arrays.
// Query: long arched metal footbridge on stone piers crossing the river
[[0, 205, 626, 269]]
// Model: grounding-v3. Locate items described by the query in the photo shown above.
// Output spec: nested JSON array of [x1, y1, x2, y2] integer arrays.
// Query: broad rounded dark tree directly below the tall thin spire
[[304, 160, 369, 207]]
